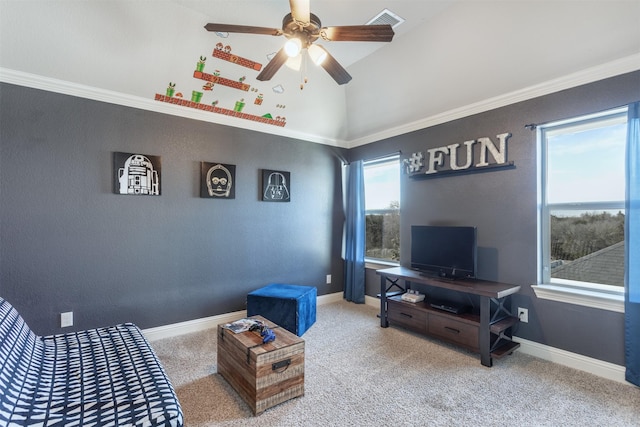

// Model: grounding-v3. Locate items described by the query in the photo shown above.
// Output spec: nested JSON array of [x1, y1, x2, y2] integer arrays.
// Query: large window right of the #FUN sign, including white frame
[[536, 108, 627, 311]]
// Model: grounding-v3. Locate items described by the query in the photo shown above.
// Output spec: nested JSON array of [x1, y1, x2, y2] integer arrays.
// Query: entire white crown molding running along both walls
[[0, 53, 640, 148]]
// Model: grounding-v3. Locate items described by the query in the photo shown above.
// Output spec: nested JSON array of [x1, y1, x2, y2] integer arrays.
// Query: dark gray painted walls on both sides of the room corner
[[0, 72, 640, 365]]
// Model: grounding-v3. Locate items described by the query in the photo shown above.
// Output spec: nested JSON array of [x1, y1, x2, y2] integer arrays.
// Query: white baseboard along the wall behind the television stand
[[365, 296, 631, 385]]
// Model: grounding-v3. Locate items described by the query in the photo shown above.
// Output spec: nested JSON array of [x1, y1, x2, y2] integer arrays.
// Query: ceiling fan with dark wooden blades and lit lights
[[204, 0, 394, 85]]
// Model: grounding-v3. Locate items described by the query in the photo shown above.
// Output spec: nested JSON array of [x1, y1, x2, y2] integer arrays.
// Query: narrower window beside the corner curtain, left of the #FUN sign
[[363, 154, 400, 263]]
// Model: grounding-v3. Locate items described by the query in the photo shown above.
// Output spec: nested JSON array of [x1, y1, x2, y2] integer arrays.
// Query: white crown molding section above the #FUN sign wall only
[[347, 53, 640, 148]]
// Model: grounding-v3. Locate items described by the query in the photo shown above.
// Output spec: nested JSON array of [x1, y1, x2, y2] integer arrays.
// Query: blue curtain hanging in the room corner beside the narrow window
[[344, 160, 365, 304]]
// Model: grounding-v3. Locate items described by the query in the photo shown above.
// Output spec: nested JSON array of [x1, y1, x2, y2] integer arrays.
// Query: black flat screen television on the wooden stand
[[411, 225, 477, 279]]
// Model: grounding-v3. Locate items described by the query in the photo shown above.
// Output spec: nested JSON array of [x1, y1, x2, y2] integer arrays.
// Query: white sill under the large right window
[[531, 284, 624, 313]]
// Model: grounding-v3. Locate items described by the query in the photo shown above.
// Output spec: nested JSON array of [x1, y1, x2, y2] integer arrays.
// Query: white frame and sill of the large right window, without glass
[[532, 107, 627, 313]]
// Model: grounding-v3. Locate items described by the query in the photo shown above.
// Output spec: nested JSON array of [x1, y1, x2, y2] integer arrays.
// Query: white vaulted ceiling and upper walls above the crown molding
[[0, 0, 640, 146]]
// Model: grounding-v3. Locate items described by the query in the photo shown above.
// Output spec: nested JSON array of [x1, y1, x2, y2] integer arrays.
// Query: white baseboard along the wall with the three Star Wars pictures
[[142, 292, 343, 341]]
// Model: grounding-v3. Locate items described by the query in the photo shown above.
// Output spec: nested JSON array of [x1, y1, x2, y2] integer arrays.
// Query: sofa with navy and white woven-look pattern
[[0, 298, 183, 427]]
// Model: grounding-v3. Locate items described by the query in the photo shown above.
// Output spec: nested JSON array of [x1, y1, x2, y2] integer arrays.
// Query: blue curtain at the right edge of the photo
[[624, 102, 640, 386]]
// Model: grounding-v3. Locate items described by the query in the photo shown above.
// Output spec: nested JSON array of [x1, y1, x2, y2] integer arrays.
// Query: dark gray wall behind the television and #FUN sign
[[349, 72, 640, 365]]
